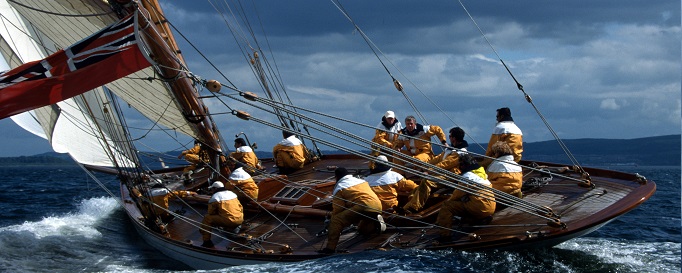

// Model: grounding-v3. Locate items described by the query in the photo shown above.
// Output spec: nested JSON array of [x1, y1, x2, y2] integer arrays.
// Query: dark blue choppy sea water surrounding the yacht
[[0, 166, 682, 273]]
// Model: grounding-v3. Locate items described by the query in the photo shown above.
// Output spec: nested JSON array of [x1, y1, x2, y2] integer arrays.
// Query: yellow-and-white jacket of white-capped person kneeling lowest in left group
[[206, 190, 244, 226]]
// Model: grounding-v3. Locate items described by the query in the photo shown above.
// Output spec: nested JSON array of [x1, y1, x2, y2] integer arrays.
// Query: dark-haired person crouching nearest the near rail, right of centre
[[436, 154, 496, 240]]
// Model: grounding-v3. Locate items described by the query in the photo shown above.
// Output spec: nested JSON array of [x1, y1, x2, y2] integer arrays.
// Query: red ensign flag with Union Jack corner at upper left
[[0, 13, 151, 119]]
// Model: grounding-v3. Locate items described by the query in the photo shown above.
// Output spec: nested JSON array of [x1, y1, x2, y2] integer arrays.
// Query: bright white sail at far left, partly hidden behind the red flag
[[0, 0, 137, 166]]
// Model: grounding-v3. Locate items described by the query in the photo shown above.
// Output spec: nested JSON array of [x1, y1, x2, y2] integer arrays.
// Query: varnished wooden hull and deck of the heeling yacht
[[111, 155, 656, 269]]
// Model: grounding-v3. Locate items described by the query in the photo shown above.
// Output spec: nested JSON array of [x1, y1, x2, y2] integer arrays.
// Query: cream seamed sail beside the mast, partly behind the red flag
[[10, 0, 196, 136]]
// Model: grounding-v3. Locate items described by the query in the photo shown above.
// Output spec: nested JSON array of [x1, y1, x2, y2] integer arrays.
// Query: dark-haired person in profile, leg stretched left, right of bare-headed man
[[403, 127, 469, 214]]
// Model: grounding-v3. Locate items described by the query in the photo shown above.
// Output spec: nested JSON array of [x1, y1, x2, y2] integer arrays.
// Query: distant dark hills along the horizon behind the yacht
[[0, 135, 682, 166]]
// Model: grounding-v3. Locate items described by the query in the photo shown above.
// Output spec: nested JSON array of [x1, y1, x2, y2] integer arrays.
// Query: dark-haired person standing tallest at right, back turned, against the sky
[[481, 107, 523, 167]]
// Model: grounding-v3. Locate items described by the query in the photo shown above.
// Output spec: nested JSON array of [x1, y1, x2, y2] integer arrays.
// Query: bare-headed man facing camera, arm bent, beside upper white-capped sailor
[[394, 116, 448, 172]]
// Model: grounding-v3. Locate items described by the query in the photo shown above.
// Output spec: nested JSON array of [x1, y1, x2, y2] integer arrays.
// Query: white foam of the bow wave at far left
[[0, 197, 118, 239]]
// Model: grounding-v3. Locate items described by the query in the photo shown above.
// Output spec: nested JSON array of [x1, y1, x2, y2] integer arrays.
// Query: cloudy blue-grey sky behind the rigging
[[0, 0, 681, 156]]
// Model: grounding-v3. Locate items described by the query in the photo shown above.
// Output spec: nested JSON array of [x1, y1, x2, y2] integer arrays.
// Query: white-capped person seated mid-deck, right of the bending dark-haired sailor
[[365, 155, 417, 211]]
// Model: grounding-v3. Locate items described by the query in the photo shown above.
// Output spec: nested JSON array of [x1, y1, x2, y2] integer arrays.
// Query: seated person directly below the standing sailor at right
[[487, 141, 523, 197]]
